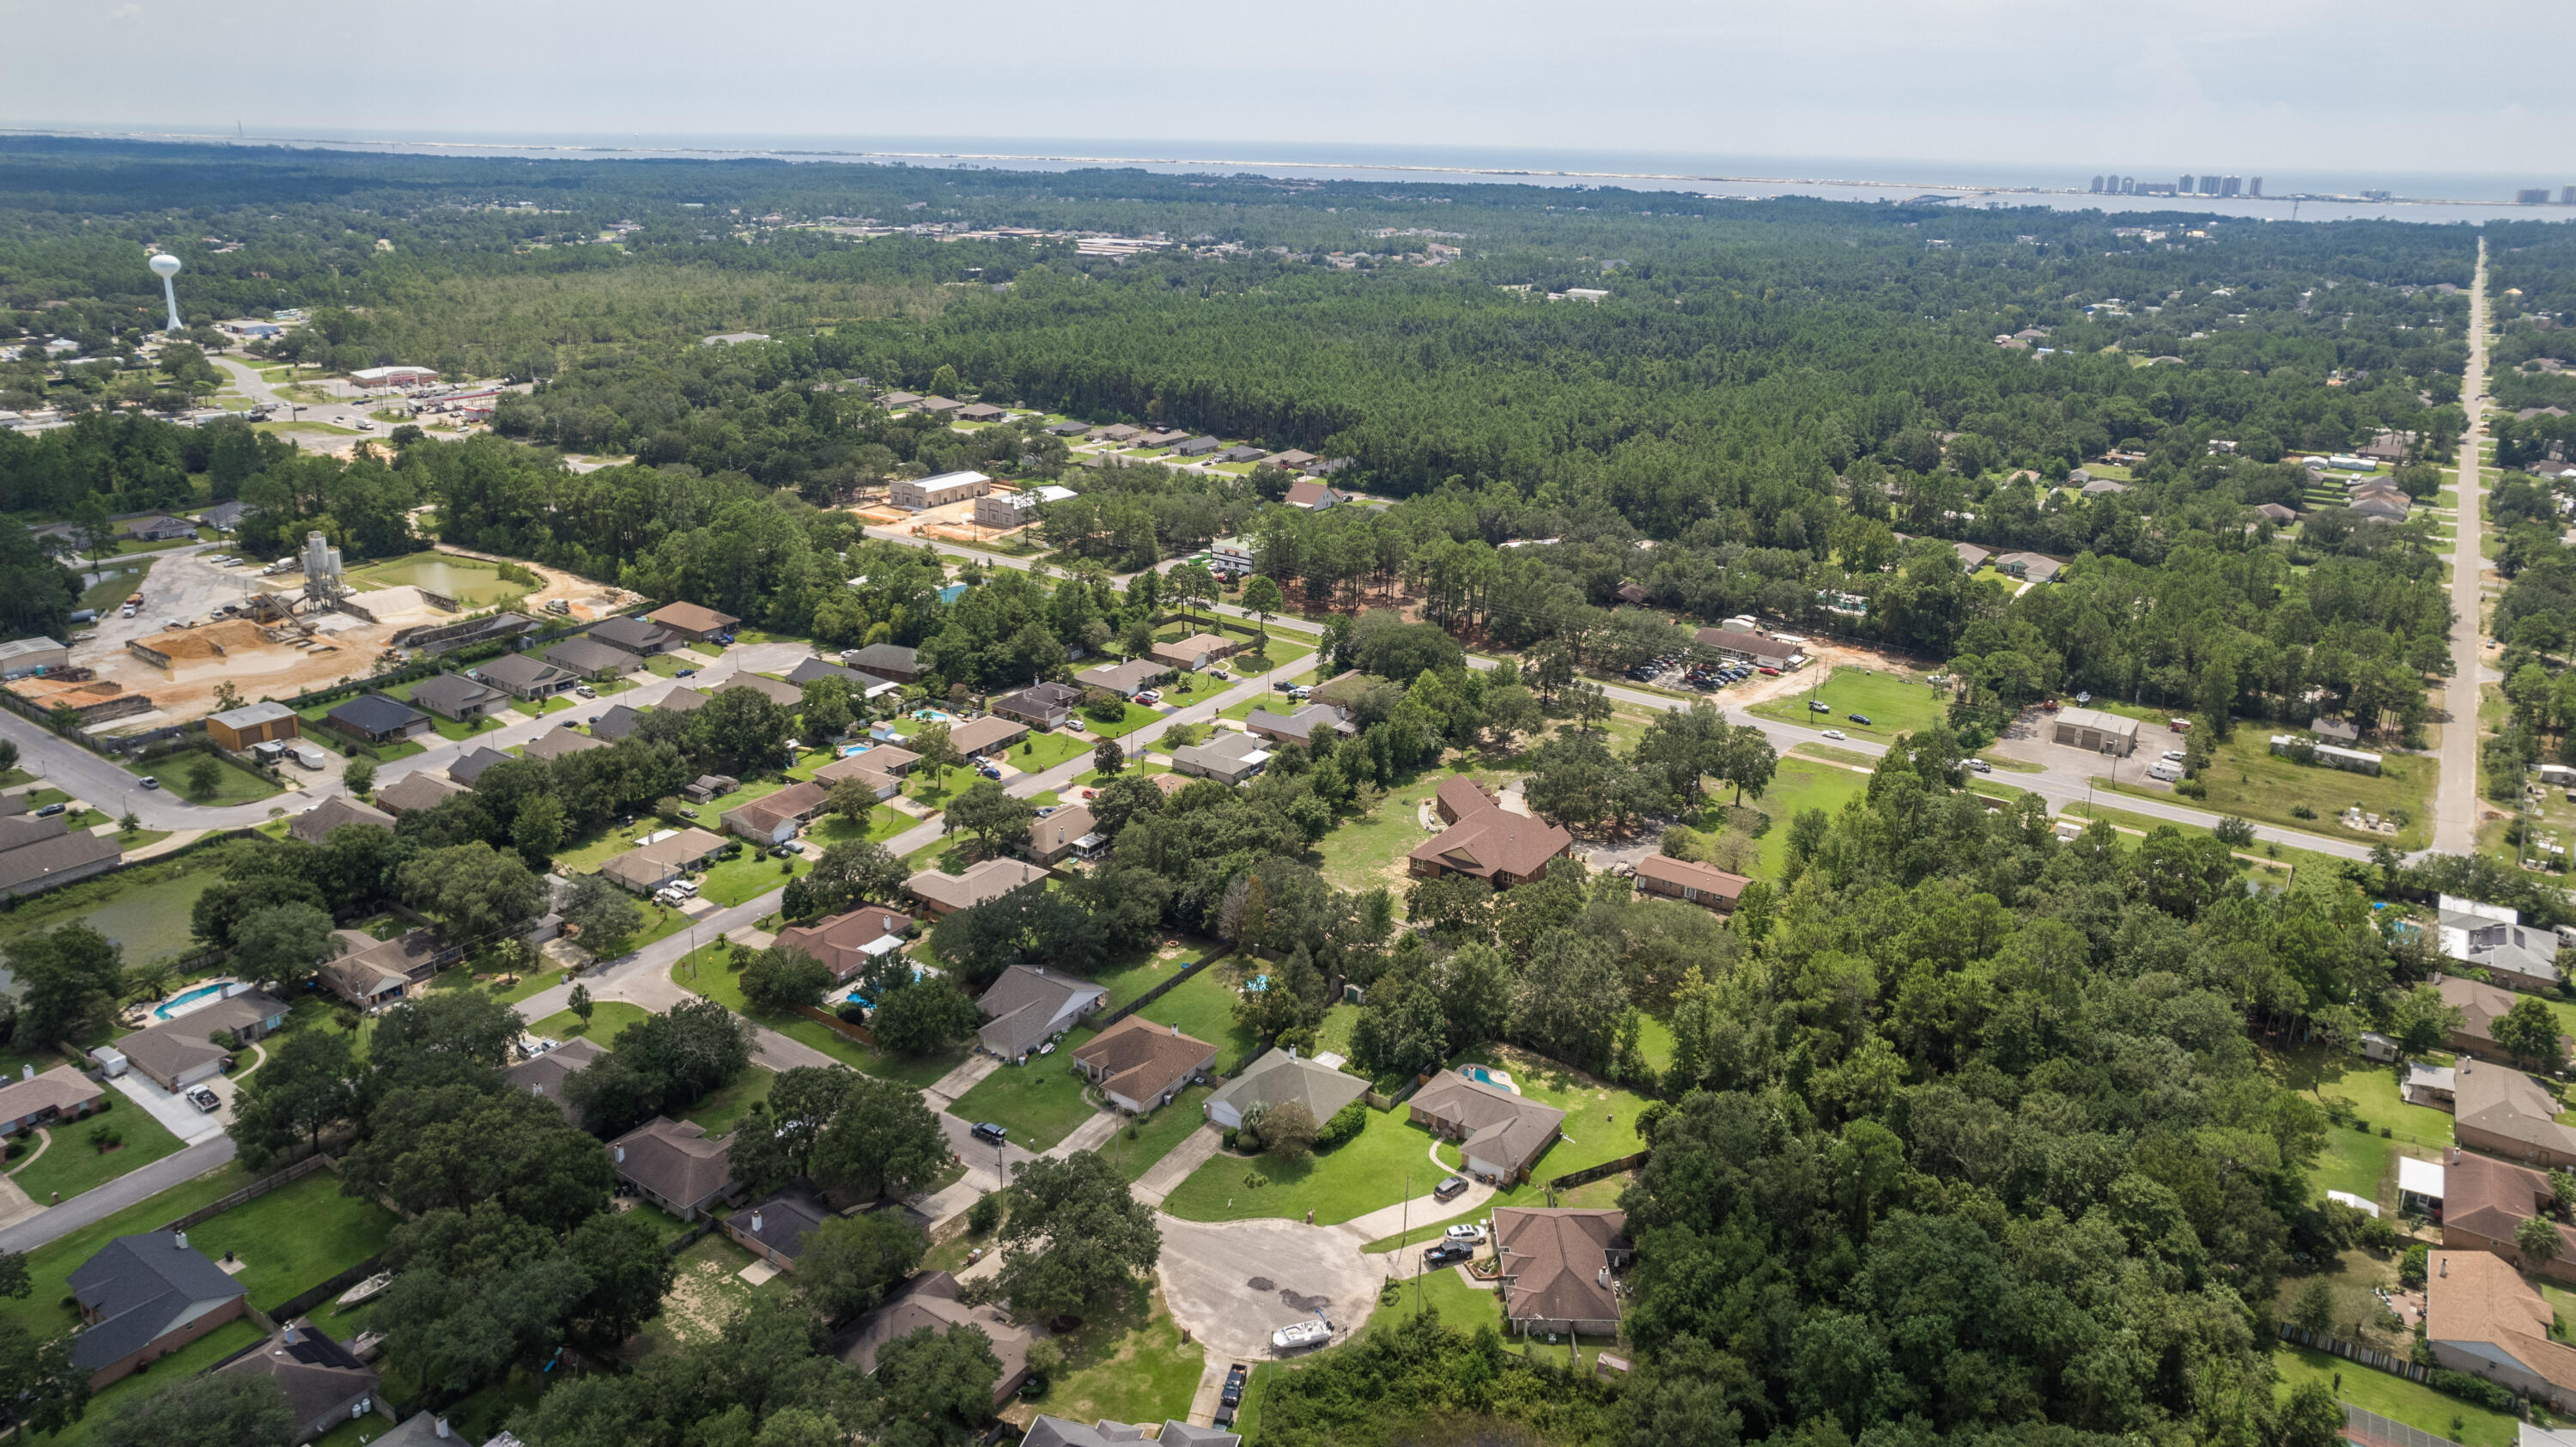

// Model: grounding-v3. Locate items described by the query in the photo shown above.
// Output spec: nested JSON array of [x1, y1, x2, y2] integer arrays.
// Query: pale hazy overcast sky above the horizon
[[0, 0, 2576, 185]]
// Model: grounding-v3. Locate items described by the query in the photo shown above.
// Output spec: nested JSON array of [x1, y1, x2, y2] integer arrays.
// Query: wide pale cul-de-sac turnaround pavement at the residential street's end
[[1154, 1215, 1386, 1362]]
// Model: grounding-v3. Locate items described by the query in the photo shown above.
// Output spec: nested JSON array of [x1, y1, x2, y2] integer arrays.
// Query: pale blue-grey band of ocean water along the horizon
[[20, 126, 2576, 224]]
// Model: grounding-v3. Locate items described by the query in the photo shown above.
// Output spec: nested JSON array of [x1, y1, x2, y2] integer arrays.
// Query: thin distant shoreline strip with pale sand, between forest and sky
[[0, 126, 2576, 219]]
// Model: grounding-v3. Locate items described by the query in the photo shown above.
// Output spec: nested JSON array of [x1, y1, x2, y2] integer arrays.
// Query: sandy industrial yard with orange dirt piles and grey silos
[[58, 533, 629, 733]]
